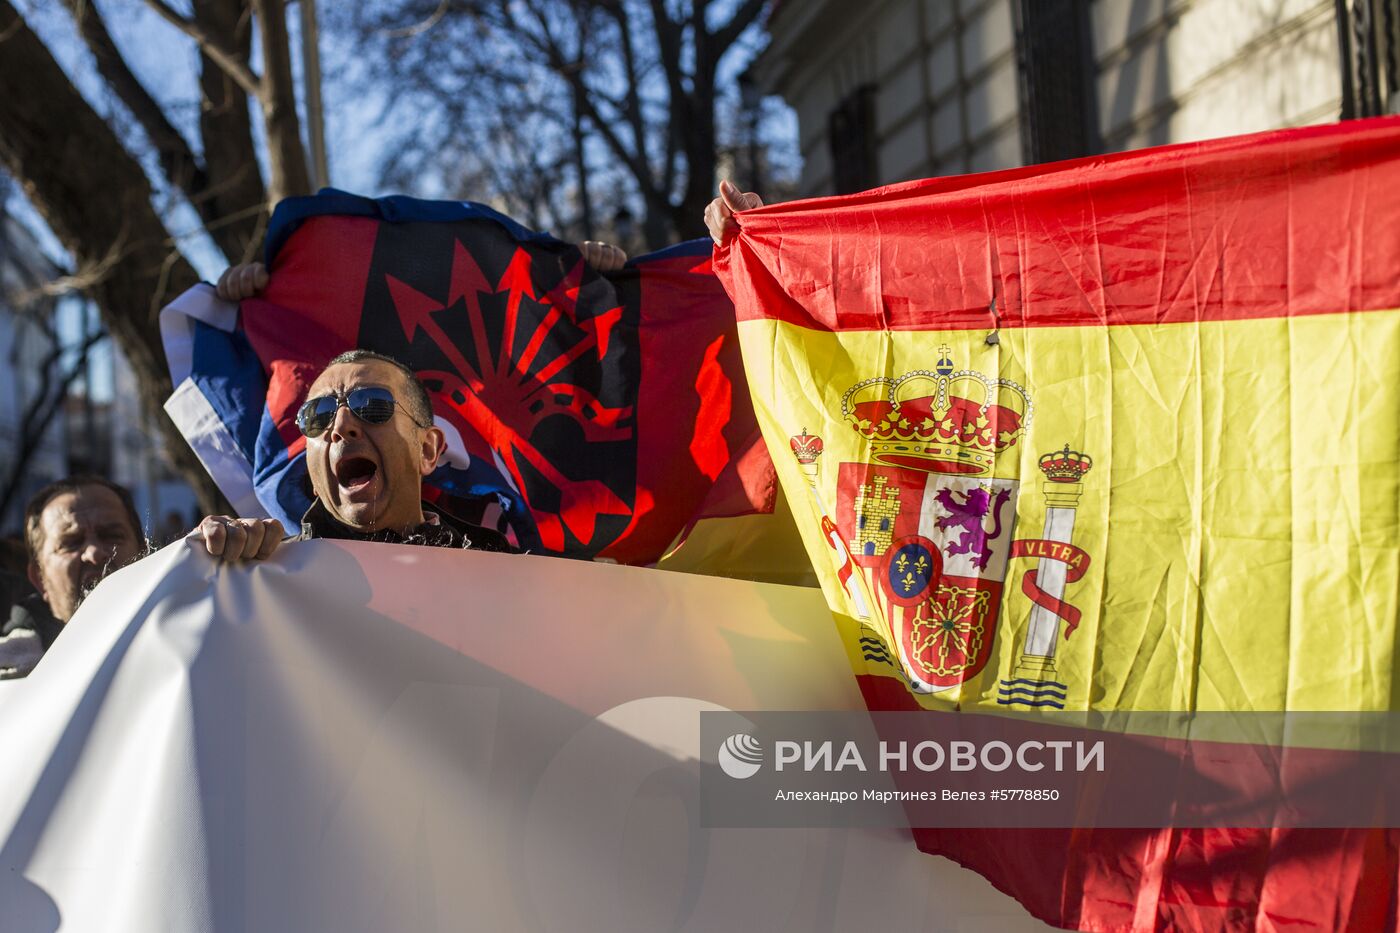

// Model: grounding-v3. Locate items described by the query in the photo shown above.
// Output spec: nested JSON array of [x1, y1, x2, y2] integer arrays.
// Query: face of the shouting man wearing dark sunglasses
[[307, 360, 442, 532]]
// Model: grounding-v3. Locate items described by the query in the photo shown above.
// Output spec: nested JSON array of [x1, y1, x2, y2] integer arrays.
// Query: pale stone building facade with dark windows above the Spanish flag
[[752, 0, 1400, 196]]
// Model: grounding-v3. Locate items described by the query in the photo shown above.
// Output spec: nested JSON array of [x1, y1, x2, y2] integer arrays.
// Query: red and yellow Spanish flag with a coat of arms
[[715, 119, 1400, 930]]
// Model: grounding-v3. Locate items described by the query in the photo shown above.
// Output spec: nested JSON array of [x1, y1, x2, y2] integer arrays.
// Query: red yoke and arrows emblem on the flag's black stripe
[[384, 241, 630, 551]]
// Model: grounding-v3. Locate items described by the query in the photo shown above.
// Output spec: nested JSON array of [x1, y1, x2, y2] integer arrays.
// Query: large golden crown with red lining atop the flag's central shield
[[841, 346, 1033, 475]]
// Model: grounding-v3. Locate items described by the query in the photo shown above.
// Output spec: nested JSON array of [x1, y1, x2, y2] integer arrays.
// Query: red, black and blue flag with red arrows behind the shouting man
[[161, 189, 774, 554]]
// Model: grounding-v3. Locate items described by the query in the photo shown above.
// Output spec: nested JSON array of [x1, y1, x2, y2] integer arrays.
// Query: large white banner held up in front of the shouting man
[[0, 542, 1046, 933]]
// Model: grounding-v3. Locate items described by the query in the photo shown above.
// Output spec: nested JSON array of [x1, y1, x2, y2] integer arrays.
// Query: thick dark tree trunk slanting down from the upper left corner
[[0, 0, 227, 511]]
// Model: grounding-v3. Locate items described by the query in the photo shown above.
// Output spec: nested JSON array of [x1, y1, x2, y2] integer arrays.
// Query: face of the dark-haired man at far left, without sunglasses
[[29, 486, 143, 622]]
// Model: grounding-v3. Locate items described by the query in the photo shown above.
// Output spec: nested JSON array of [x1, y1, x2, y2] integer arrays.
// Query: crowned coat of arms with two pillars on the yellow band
[[790, 343, 1092, 707]]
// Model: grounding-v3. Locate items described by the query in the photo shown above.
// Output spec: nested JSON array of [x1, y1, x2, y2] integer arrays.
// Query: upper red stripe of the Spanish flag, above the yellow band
[[715, 118, 1400, 331]]
